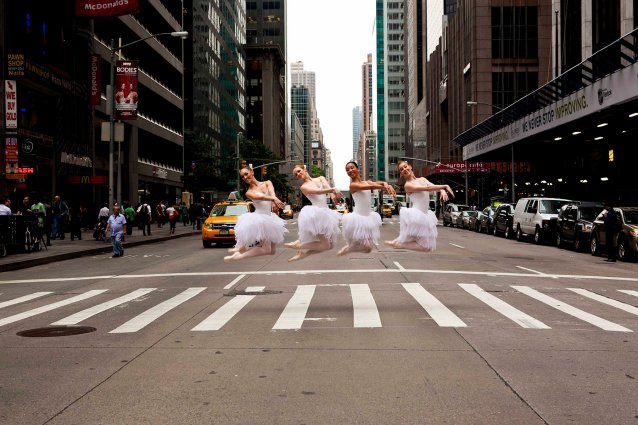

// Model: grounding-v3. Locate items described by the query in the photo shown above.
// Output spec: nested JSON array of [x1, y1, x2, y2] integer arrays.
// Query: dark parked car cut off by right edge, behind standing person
[[590, 207, 638, 261]]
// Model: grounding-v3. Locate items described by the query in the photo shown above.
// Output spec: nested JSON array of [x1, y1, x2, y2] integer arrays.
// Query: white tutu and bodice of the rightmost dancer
[[398, 192, 438, 251]]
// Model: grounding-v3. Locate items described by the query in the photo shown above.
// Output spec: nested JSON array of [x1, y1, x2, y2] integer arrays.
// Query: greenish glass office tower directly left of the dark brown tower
[[184, 0, 246, 195]]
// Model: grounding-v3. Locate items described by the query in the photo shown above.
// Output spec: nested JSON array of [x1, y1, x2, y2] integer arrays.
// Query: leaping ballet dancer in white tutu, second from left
[[284, 165, 341, 261]]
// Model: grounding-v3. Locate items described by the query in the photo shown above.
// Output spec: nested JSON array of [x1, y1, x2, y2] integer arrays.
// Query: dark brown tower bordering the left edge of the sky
[[246, 0, 289, 158]]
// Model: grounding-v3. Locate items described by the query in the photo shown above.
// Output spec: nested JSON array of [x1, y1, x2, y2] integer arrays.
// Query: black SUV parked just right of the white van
[[556, 202, 603, 251]]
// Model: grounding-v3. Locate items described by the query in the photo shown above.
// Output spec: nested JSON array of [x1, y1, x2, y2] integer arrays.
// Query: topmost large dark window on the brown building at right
[[492, 6, 538, 59]]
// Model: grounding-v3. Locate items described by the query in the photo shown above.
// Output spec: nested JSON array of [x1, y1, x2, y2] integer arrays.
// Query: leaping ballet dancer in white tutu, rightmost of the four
[[385, 161, 454, 252]]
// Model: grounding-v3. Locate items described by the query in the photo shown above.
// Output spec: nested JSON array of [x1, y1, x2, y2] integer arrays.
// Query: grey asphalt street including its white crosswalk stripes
[[0, 220, 638, 424]]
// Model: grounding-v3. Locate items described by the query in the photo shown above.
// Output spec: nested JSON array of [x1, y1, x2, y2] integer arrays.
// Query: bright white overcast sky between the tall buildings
[[287, 0, 376, 189]]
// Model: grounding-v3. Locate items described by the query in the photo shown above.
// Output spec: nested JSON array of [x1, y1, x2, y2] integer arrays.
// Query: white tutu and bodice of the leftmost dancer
[[235, 201, 288, 247]]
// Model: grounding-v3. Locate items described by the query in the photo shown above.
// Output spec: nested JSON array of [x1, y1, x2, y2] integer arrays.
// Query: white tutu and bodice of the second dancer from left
[[298, 195, 341, 244]]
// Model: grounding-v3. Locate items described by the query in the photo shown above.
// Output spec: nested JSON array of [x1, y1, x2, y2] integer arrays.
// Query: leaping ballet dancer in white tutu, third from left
[[337, 161, 396, 255]]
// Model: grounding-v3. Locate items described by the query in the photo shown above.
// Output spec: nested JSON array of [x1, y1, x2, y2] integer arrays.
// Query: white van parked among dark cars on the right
[[512, 198, 574, 244]]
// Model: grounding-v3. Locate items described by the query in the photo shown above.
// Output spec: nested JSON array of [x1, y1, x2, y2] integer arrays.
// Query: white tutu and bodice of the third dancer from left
[[342, 190, 381, 245]]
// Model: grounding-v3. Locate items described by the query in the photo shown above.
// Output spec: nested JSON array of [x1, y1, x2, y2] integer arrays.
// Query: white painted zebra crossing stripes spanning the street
[[0, 283, 638, 334]]
